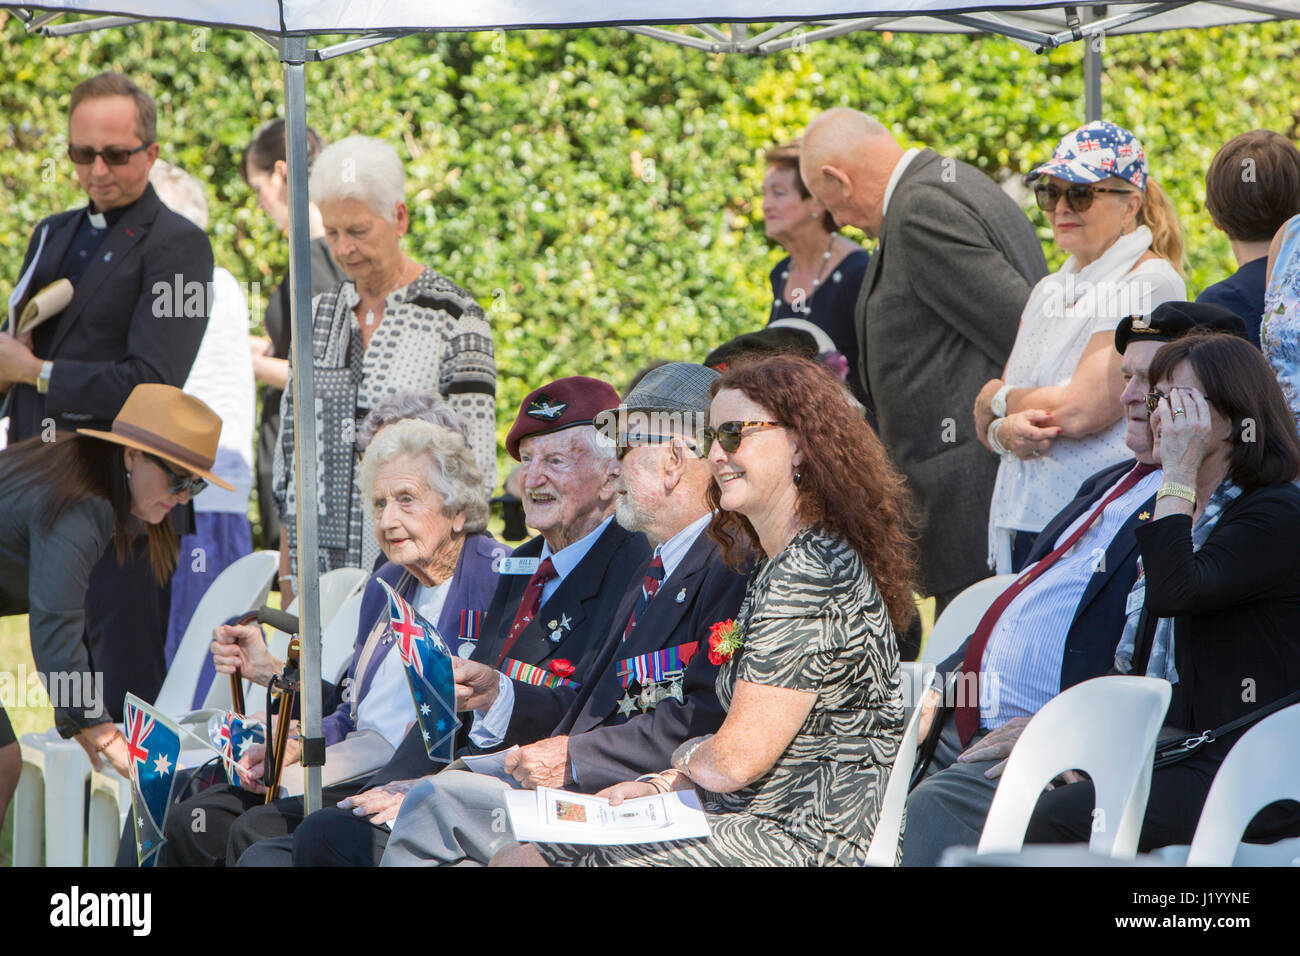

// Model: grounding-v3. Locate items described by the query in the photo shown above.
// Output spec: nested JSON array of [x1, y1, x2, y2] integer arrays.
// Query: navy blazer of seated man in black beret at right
[[939, 459, 1156, 691]]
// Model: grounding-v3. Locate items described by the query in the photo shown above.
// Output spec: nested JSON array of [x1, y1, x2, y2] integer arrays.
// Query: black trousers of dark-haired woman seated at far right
[[1024, 750, 1300, 853]]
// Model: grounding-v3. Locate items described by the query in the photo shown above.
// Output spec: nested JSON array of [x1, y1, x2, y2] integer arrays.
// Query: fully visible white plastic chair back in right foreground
[[979, 676, 1170, 860]]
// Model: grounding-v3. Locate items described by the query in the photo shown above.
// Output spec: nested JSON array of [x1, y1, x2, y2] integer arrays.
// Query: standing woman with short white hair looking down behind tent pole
[[274, 137, 497, 601]]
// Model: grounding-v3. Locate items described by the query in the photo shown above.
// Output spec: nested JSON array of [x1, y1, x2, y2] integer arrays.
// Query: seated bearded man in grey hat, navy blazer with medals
[[294, 363, 745, 865]]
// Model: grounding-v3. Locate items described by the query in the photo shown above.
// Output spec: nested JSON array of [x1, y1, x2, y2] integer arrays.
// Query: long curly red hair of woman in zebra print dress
[[709, 355, 917, 633]]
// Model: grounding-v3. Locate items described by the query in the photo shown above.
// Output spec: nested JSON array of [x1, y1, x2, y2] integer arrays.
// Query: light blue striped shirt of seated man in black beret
[[980, 468, 1164, 730]]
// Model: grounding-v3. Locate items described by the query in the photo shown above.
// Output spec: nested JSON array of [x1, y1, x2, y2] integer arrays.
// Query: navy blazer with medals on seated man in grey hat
[[561, 532, 746, 793]]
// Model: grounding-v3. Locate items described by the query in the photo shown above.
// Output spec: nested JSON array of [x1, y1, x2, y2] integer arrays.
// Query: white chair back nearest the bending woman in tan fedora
[[153, 551, 280, 717]]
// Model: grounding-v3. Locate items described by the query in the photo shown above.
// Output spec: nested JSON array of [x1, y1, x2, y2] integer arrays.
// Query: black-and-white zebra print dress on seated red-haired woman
[[537, 528, 904, 866]]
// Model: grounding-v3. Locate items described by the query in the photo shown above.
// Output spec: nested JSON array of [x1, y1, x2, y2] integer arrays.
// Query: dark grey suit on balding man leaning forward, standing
[[857, 150, 1048, 594]]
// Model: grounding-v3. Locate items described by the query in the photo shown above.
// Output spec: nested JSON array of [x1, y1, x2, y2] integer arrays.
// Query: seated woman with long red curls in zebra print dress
[[495, 356, 915, 866]]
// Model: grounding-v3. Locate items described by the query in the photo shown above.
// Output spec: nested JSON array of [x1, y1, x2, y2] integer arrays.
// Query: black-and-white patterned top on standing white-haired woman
[[273, 268, 497, 574]]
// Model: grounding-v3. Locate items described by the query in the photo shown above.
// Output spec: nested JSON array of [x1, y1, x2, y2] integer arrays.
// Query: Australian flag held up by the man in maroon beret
[[380, 580, 460, 763]]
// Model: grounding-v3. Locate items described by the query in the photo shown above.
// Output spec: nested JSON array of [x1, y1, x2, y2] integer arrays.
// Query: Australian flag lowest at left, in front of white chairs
[[125, 693, 181, 866]]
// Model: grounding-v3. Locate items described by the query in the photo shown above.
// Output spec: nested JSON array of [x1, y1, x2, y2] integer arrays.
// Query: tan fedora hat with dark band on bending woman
[[77, 385, 234, 492]]
